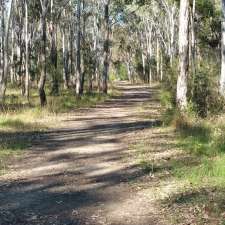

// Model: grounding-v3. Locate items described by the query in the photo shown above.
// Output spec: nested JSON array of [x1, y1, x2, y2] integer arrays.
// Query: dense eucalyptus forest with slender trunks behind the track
[[0, 0, 224, 117]]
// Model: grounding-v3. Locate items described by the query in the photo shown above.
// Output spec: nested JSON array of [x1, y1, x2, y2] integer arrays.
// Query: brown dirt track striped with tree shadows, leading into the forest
[[0, 83, 168, 225]]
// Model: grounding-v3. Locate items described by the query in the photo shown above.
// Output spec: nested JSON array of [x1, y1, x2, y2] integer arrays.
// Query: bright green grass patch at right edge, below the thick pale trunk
[[172, 120, 225, 187]]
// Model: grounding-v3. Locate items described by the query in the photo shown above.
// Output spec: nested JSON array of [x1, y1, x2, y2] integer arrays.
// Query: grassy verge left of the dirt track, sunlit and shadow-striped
[[0, 85, 116, 173]]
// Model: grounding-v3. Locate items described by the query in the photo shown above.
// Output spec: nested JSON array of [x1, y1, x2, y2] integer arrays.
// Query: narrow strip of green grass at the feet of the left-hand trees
[[1, 87, 118, 113]]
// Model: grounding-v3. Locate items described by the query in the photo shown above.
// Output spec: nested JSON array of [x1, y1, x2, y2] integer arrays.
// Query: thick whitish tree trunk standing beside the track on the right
[[177, 0, 189, 111]]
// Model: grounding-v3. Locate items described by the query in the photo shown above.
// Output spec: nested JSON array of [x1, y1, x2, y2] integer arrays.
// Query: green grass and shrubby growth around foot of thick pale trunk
[[160, 87, 225, 187]]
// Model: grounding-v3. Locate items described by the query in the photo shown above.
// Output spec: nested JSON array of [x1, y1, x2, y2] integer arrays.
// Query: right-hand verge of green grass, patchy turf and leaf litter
[[130, 98, 225, 225]]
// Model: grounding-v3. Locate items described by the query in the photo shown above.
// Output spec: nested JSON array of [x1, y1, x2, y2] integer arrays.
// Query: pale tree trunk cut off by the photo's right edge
[[220, 0, 225, 97]]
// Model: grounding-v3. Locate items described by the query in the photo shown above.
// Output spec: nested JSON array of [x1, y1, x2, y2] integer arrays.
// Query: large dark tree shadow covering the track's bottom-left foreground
[[0, 163, 153, 225]]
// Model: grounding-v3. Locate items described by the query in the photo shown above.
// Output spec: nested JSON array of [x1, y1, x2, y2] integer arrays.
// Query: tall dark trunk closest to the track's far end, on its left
[[102, 0, 110, 94]]
